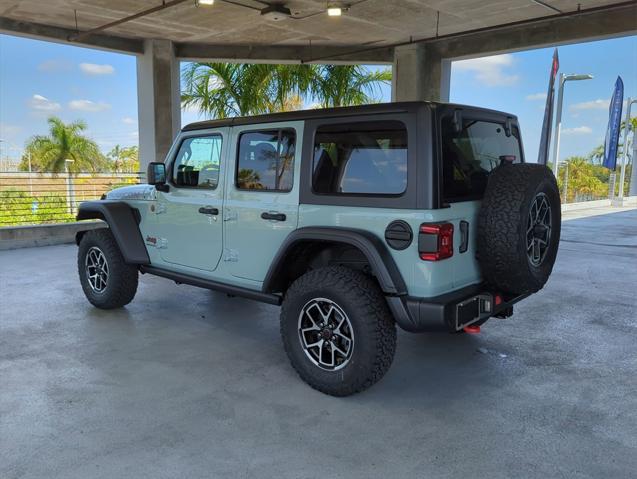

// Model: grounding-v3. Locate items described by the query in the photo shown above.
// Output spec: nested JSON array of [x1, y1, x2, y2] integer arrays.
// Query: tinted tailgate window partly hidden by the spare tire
[[442, 117, 522, 202]]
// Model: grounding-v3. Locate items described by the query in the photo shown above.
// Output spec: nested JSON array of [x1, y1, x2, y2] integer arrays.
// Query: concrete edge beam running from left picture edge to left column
[[0, 17, 144, 55]]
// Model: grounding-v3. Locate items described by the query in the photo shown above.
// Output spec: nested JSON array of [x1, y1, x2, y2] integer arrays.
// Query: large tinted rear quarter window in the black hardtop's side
[[312, 121, 407, 195]]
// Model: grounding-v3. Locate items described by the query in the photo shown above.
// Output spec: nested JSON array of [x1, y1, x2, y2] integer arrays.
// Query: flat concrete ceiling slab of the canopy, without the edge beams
[[0, 0, 622, 46]]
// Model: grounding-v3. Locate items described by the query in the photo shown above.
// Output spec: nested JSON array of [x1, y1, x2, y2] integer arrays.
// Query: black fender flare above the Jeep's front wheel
[[76, 200, 150, 264]]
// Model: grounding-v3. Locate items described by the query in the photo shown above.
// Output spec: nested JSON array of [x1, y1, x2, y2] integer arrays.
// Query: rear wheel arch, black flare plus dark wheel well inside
[[262, 227, 407, 296]]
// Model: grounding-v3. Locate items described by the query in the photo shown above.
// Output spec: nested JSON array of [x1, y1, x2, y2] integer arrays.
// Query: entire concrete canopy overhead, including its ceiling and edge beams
[[0, 0, 637, 63]]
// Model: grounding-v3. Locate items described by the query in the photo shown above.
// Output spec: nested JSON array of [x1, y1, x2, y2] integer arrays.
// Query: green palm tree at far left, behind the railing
[[23, 116, 105, 173]]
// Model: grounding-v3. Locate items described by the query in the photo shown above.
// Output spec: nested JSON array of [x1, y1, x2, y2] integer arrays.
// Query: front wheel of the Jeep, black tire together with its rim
[[77, 228, 139, 309]]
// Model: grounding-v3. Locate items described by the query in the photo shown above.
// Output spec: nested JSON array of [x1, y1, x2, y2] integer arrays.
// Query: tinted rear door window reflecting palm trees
[[236, 130, 296, 191]]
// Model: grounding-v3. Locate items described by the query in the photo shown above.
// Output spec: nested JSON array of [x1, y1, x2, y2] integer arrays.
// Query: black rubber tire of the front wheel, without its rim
[[77, 228, 139, 309]]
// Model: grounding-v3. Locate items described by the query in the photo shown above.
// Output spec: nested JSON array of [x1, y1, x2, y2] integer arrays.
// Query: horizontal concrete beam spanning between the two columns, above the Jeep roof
[[175, 43, 394, 65]]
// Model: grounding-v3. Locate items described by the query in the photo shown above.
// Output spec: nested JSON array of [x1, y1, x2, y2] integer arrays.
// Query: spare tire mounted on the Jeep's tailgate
[[477, 163, 562, 294]]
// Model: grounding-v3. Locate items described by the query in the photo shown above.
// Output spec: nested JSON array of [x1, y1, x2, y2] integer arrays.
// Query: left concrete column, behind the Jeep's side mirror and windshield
[[137, 40, 181, 172]]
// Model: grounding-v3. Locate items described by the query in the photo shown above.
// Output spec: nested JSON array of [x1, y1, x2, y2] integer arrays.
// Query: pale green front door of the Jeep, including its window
[[156, 129, 227, 271]]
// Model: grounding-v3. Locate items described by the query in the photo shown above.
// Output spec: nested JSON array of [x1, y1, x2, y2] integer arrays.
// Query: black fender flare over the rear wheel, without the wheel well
[[262, 226, 407, 296]]
